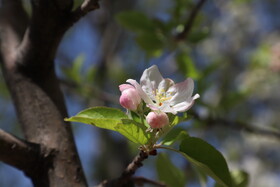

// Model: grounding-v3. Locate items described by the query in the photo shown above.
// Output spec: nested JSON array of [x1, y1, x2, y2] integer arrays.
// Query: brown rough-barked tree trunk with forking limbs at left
[[0, 0, 98, 187]]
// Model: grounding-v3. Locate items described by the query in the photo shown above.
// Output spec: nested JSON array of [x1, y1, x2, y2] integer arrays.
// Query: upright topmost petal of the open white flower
[[140, 65, 163, 97]]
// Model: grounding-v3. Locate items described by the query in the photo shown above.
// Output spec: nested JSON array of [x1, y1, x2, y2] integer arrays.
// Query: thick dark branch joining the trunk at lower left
[[0, 129, 40, 173]]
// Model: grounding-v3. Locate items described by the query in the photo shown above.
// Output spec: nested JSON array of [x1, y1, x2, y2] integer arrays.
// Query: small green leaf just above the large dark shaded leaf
[[162, 128, 189, 145]]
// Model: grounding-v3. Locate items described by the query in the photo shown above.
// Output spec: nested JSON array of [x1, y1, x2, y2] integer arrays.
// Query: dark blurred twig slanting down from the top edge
[[175, 0, 206, 41]]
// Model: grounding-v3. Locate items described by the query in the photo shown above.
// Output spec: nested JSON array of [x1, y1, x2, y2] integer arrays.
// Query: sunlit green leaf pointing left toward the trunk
[[65, 107, 127, 131]]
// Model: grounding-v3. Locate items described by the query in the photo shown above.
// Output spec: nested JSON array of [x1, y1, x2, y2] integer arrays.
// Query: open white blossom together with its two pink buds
[[119, 66, 199, 129]]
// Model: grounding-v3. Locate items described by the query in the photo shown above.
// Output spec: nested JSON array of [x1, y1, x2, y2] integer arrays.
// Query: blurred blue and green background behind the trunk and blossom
[[0, 0, 280, 187]]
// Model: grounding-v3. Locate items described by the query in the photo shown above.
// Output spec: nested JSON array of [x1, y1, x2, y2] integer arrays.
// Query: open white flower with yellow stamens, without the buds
[[127, 65, 199, 114]]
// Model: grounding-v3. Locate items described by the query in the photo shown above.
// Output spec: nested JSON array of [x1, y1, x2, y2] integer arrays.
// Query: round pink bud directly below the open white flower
[[146, 112, 169, 129]]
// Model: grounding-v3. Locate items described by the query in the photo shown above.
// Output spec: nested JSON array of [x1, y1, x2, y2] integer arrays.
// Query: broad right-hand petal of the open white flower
[[168, 78, 194, 105]]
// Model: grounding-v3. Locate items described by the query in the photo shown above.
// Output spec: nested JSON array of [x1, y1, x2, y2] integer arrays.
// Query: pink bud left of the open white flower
[[120, 87, 141, 111]]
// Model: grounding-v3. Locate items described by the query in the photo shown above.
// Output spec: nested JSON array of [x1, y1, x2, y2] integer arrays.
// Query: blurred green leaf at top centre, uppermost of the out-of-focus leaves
[[116, 11, 155, 33]]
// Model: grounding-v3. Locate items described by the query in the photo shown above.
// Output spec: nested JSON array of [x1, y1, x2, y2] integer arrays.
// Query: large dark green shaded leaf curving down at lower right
[[179, 137, 232, 187]]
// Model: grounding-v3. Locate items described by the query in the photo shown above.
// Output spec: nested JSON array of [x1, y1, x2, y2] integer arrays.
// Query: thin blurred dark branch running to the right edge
[[192, 113, 280, 140]]
